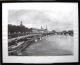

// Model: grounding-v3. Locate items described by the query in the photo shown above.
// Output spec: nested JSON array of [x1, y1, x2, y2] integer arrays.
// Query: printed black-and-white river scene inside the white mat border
[[8, 10, 74, 56]]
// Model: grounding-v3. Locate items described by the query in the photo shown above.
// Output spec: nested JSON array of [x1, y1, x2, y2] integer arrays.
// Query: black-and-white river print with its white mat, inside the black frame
[[3, 3, 78, 63]]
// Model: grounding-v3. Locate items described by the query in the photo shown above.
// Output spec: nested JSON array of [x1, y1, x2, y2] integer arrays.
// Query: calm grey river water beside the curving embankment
[[21, 35, 74, 56]]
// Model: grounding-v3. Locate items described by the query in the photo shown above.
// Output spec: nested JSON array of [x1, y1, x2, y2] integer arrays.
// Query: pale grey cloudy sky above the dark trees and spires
[[8, 10, 73, 31]]
